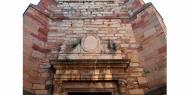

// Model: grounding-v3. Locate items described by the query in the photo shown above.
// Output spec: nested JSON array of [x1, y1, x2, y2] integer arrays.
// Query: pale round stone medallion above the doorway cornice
[[82, 35, 99, 52]]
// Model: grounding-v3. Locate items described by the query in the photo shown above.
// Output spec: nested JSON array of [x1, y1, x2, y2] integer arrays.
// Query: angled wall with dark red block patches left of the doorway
[[23, 5, 48, 94]]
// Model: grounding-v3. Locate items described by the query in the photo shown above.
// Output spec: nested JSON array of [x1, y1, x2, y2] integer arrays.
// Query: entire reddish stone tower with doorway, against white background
[[23, 0, 166, 95]]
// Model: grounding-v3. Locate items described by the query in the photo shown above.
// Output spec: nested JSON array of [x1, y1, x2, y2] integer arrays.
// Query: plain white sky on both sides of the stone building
[[0, 0, 190, 95]]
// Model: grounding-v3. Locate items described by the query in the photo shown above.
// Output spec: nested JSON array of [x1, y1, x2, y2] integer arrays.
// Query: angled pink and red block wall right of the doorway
[[132, 6, 166, 88]]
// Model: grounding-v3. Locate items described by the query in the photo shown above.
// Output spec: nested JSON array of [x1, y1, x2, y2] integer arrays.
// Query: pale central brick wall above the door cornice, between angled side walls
[[44, 0, 143, 60]]
